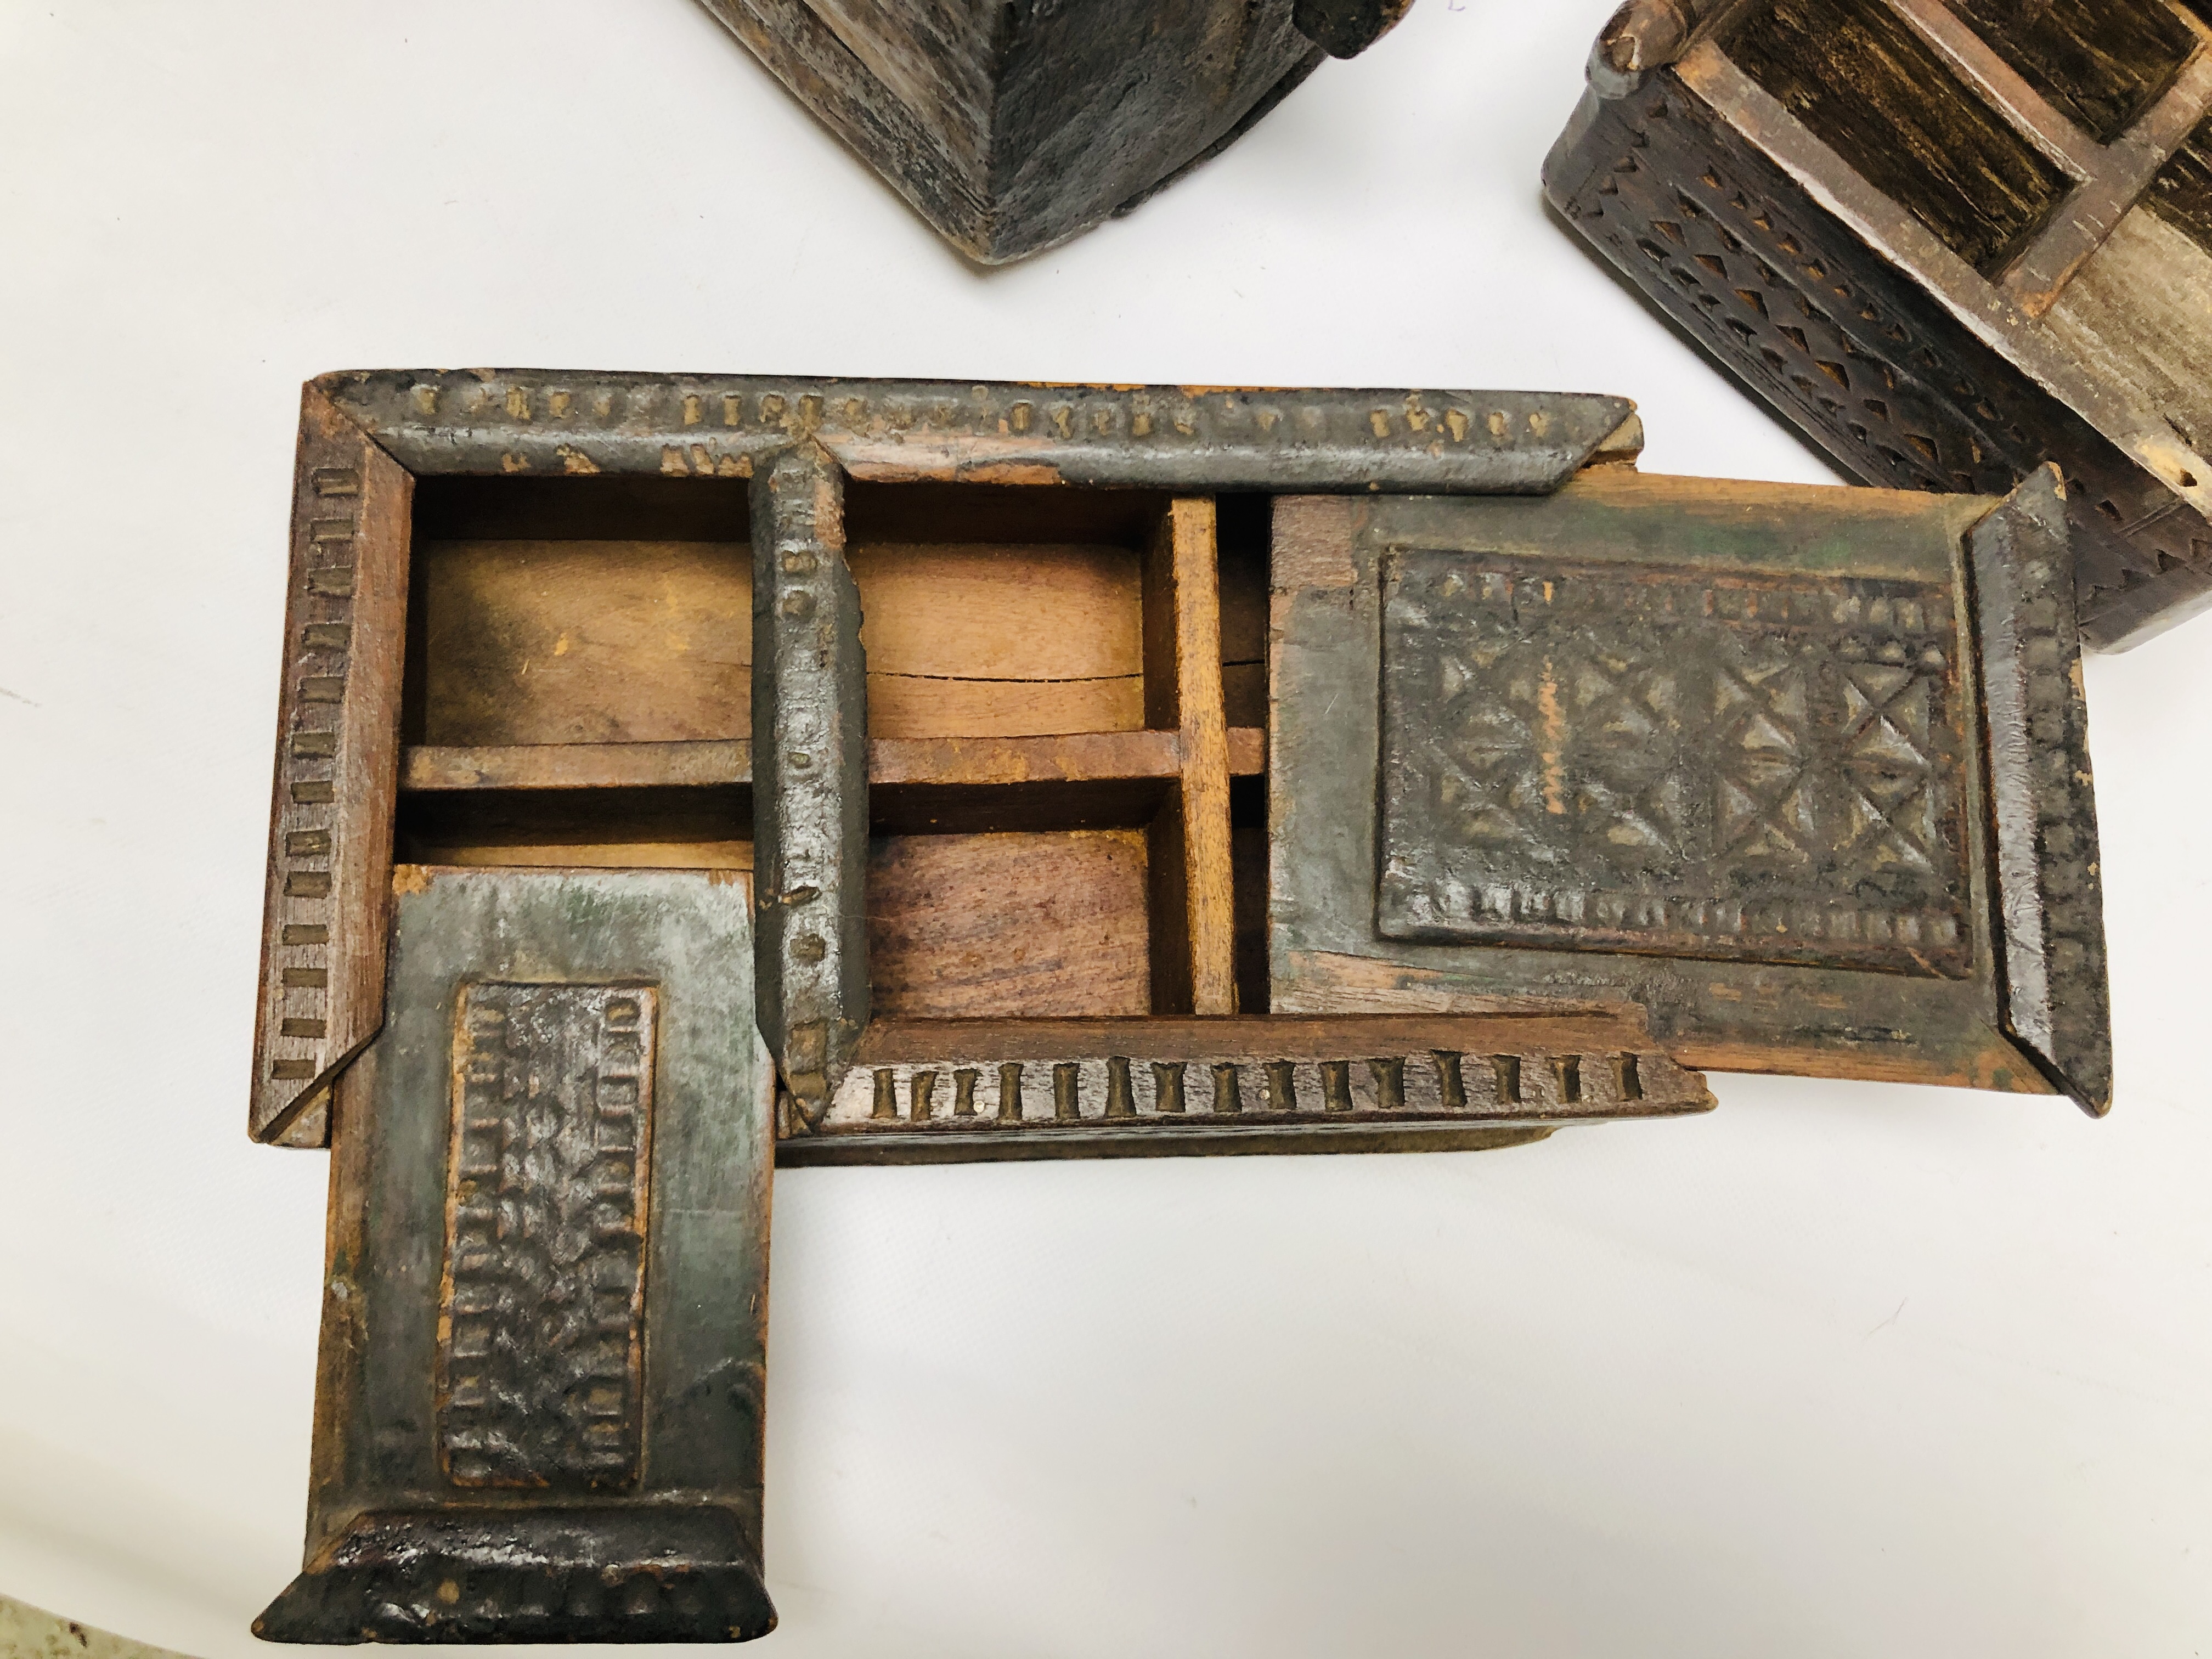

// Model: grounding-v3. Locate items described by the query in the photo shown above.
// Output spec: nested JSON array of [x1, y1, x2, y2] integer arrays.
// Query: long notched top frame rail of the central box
[[317, 369, 1635, 495]]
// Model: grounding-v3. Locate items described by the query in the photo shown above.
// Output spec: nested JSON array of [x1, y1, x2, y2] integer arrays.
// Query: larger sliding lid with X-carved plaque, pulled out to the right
[[1269, 471, 2106, 1108]]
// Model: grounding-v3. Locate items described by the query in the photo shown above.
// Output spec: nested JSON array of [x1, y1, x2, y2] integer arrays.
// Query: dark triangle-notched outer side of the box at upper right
[[1546, 77, 2212, 637]]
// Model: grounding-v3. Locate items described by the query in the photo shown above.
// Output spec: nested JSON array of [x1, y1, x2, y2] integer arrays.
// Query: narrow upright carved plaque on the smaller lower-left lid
[[438, 984, 657, 1491]]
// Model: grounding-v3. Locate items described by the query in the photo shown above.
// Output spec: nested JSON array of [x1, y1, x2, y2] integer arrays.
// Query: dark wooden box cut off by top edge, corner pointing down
[[706, 0, 1411, 266]]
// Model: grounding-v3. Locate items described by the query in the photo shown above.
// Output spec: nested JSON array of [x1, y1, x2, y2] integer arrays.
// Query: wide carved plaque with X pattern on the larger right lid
[[1376, 549, 1973, 978]]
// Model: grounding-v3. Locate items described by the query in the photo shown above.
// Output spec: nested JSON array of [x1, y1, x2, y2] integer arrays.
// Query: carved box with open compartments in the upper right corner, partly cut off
[[1544, 0, 2212, 648]]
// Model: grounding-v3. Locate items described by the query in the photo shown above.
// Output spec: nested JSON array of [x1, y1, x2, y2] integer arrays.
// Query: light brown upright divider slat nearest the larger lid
[[1161, 498, 1237, 1015]]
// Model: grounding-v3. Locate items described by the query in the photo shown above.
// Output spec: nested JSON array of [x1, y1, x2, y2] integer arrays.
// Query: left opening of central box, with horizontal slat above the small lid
[[398, 478, 752, 870]]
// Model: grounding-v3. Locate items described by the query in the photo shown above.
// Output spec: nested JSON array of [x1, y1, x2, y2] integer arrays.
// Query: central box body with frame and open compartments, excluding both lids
[[250, 371, 1710, 1161]]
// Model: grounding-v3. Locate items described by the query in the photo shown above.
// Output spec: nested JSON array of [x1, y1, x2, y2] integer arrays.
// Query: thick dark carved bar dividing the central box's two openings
[[752, 444, 867, 1117]]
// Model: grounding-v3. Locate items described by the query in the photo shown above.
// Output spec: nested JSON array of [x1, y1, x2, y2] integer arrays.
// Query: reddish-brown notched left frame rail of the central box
[[248, 385, 414, 1146]]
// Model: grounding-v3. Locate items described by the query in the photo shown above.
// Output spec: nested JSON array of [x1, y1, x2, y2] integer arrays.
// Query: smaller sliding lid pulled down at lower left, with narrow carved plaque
[[255, 867, 774, 1641]]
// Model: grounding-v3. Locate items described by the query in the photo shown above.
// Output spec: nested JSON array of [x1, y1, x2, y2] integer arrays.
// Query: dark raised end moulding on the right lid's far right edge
[[1968, 467, 2113, 1117]]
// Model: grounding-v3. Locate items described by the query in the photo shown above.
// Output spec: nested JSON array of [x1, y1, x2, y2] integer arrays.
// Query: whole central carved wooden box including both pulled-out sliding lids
[[252, 371, 2108, 1641]]
